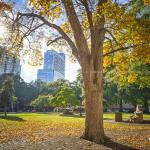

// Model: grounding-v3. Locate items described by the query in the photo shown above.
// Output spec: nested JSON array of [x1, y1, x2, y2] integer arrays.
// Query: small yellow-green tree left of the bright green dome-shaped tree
[[31, 95, 53, 110]]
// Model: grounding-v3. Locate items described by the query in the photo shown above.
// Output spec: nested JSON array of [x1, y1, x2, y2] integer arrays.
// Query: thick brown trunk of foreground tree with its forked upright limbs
[[62, 0, 105, 143]]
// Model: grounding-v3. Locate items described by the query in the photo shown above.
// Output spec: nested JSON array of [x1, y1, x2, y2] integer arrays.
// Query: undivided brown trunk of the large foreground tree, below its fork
[[82, 56, 104, 143]]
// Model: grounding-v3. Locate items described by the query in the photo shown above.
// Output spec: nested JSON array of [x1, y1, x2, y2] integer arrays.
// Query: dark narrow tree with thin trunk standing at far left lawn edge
[[0, 76, 15, 117]]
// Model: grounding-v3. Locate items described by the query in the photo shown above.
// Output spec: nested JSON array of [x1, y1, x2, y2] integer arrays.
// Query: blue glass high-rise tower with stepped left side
[[37, 50, 65, 82]]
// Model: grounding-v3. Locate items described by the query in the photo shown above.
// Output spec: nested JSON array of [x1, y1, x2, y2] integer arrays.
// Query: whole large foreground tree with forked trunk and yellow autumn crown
[[9, 0, 149, 143]]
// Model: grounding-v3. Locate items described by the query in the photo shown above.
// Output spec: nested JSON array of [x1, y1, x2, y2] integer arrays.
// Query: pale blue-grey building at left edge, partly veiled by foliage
[[0, 54, 21, 75]]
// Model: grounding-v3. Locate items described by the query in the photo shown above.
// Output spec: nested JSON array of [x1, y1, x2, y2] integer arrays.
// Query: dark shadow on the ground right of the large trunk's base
[[103, 138, 137, 150]]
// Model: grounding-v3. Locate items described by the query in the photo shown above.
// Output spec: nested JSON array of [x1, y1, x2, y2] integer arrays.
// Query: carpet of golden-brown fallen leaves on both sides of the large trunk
[[0, 114, 150, 149]]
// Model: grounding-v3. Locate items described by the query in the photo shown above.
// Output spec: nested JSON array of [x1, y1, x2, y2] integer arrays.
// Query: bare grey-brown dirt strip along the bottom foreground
[[0, 137, 127, 150]]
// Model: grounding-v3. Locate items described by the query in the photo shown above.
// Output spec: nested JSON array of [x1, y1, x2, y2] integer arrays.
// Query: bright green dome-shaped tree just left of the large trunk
[[51, 86, 79, 107]]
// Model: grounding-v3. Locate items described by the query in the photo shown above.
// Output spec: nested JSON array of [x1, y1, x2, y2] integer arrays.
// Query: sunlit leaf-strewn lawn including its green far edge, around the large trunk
[[0, 113, 150, 150]]
